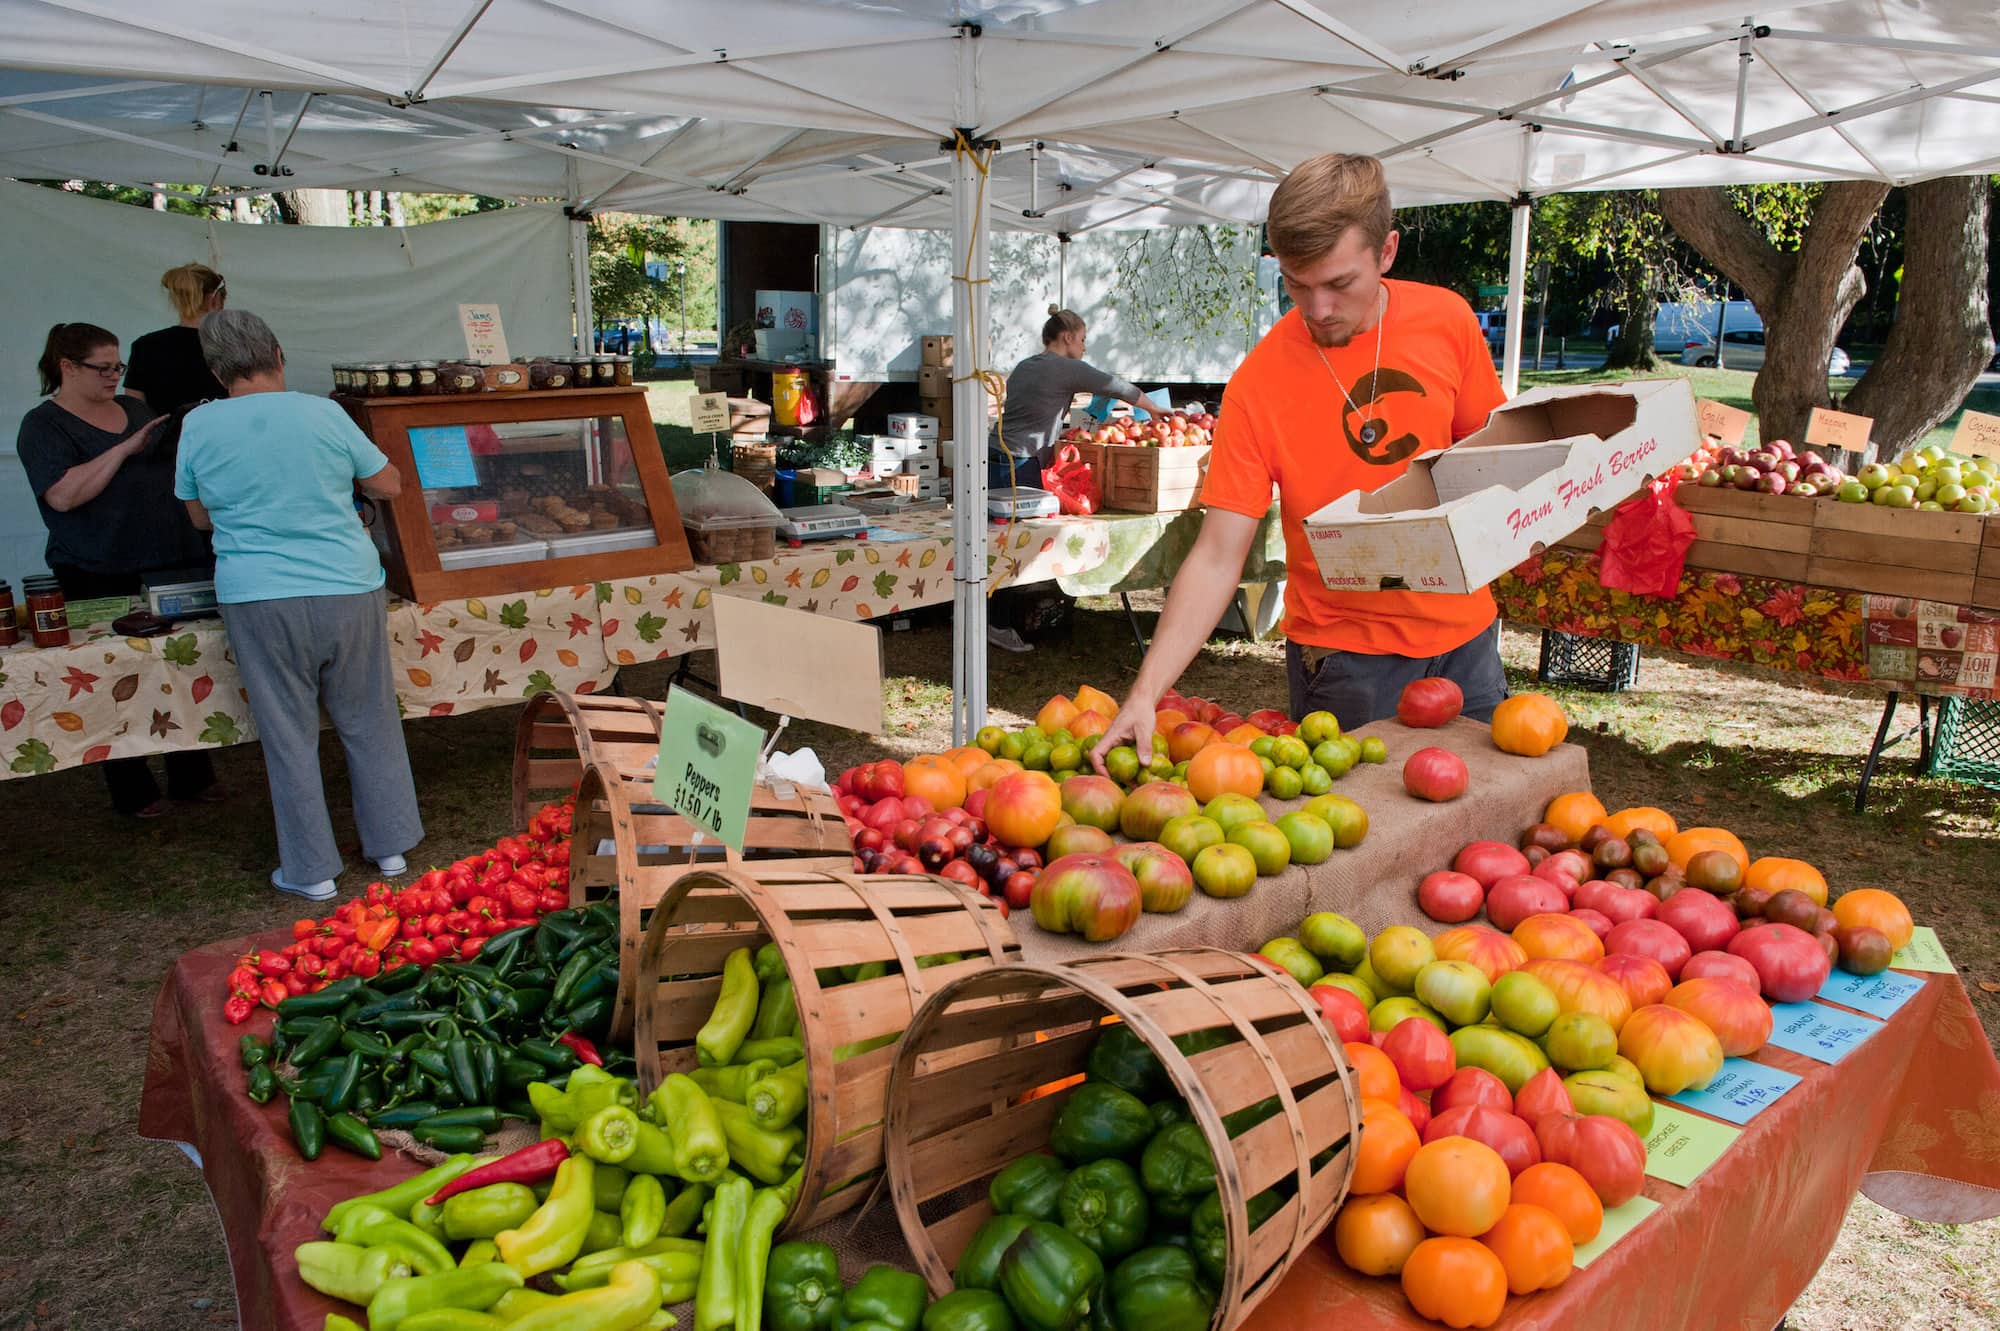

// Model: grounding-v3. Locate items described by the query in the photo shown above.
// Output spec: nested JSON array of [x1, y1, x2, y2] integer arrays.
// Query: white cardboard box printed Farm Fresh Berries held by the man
[[1304, 380, 1700, 592]]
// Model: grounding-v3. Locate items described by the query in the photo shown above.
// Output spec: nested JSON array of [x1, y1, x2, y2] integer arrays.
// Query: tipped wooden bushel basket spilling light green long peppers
[[620, 863, 1020, 1235]]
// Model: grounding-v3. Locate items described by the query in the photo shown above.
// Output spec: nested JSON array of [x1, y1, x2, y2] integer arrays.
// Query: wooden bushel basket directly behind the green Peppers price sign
[[570, 755, 854, 1041]]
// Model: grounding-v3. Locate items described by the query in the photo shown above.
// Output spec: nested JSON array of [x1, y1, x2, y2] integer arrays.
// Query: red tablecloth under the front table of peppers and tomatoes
[[140, 935, 2000, 1331]]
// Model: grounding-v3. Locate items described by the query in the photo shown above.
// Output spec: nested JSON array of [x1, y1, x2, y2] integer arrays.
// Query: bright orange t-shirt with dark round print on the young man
[[1202, 282, 1506, 658]]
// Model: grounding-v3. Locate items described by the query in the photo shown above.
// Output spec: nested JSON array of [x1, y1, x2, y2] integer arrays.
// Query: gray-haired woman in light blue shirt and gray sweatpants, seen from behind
[[174, 310, 424, 901]]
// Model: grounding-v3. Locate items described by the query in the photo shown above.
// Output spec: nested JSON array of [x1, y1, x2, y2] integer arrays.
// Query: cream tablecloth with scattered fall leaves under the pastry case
[[0, 514, 1110, 779]]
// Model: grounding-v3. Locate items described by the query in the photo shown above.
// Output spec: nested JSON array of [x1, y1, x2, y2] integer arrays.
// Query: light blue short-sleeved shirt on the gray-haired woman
[[174, 394, 388, 606]]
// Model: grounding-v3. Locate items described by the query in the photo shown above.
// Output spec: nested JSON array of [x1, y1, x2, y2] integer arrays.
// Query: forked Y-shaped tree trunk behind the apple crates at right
[[1660, 180, 1888, 440]]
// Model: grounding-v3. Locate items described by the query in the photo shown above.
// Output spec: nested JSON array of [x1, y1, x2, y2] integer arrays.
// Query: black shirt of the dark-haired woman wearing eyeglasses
[[14, 396, 212, 574]]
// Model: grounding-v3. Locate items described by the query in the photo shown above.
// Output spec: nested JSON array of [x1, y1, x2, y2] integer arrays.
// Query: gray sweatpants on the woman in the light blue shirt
[[222, 588, 424, 887]]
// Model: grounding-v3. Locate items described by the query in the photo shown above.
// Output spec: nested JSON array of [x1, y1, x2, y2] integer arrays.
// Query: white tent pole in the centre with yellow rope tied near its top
[[940, 142, 988, 743]]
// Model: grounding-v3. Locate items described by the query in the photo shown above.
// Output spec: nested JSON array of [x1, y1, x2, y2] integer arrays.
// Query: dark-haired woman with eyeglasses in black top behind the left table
[[14, 324, 222, 817]]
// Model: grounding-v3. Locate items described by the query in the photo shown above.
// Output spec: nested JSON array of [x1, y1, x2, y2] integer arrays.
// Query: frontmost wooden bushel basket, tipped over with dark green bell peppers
[[886, 947, 1360, 1331]]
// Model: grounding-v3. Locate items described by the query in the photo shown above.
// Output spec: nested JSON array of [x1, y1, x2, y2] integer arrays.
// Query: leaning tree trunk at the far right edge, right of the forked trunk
[[1846, 176, 1994, 458]]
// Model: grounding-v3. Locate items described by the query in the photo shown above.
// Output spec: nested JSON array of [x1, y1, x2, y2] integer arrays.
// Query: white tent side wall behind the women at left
[[0, 182, 574, 578]]
